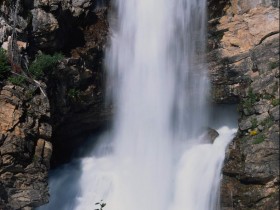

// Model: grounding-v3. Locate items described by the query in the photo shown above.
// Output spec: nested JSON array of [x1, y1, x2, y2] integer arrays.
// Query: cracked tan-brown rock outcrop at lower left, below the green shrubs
[[0, 85, 52, 209]]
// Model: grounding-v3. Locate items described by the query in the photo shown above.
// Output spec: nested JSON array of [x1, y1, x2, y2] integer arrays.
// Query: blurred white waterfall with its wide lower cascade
[[40, 0, 236, 210]]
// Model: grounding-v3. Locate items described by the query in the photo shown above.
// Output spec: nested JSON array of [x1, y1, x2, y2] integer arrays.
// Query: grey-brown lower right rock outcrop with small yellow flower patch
[[222, 37, 279, 210]]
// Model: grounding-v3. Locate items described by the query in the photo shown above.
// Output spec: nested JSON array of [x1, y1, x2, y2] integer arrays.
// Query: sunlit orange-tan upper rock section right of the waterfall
[[208, 4, 279, 103]]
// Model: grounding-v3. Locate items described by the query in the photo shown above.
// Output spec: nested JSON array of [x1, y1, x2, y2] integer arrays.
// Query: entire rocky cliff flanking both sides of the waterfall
[[0, 0, 279, 210]]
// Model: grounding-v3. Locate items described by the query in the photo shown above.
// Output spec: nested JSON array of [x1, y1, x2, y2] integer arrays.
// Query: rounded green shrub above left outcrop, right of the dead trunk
[[29, 53, 63, 79]]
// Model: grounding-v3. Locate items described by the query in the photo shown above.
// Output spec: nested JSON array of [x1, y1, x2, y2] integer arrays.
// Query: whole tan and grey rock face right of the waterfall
[[208, 0, 279, 210]]
